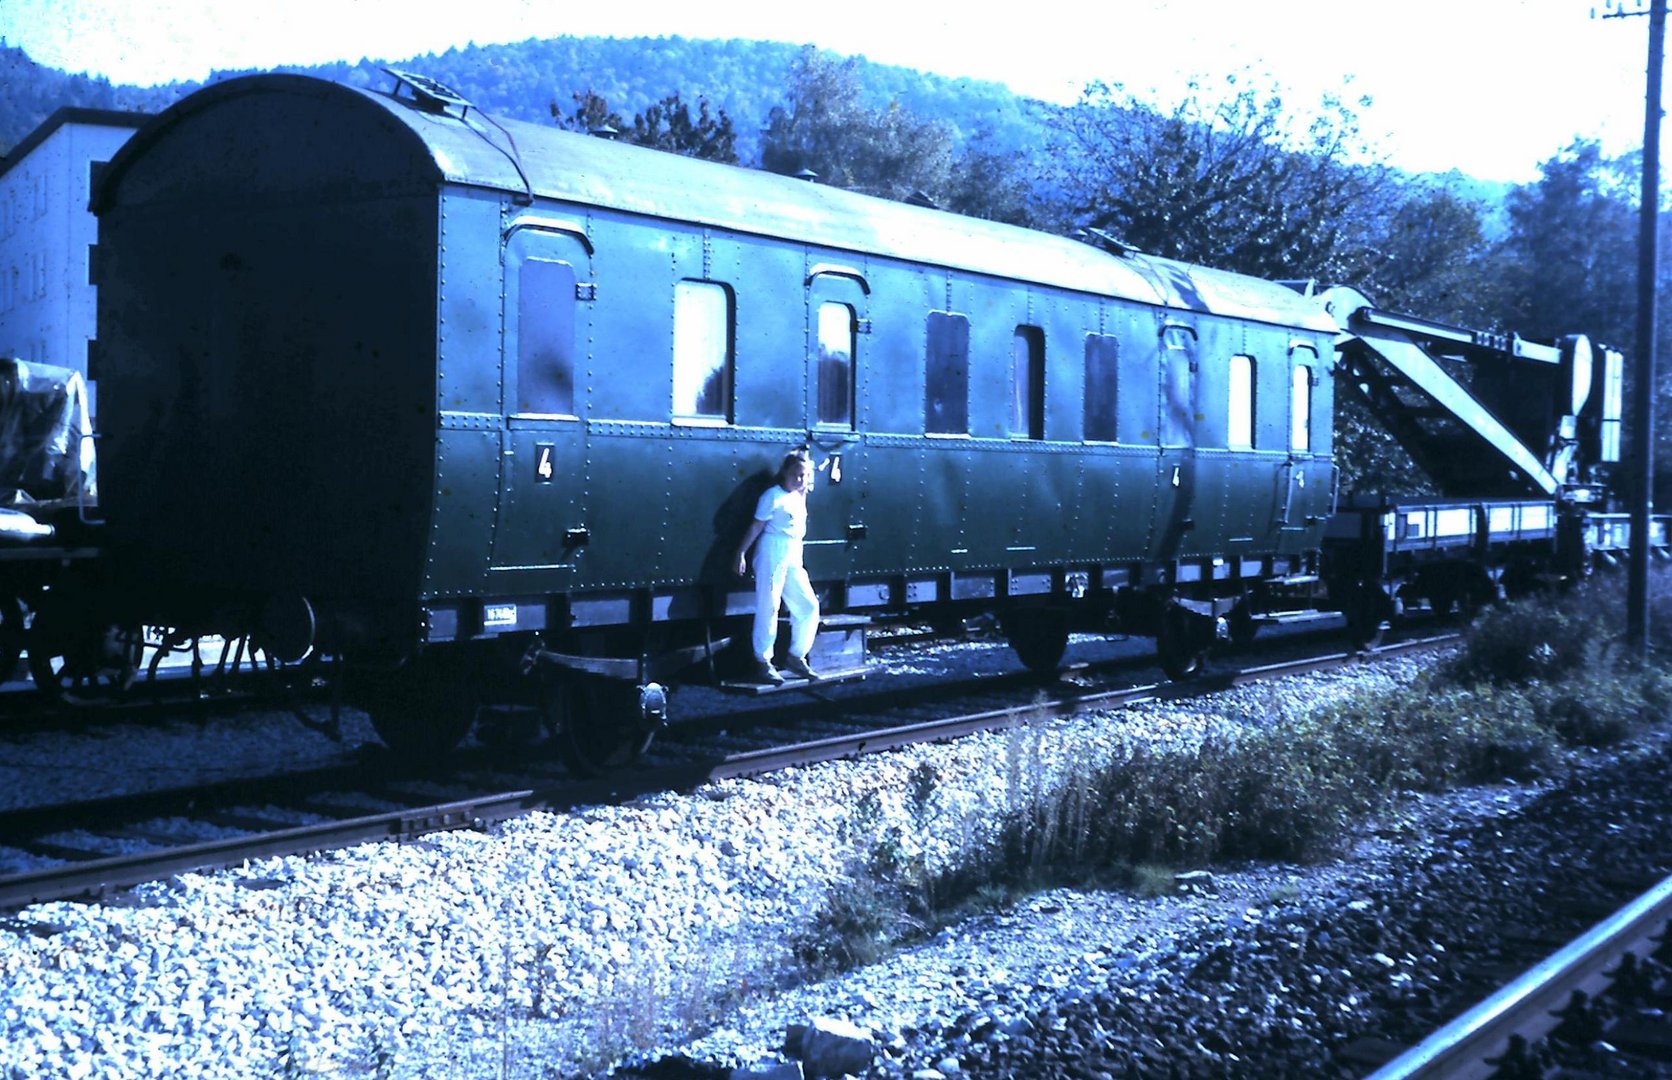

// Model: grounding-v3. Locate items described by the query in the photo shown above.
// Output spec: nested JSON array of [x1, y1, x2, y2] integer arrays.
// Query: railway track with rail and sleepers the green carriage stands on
[[0, 635, 1455, 909]]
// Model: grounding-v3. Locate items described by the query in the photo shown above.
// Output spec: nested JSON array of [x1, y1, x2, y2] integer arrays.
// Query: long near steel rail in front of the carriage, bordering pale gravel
[[0, 634, 1458, 911]]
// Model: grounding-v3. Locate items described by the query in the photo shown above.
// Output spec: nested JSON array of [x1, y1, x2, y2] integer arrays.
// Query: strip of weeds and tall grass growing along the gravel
[[796, 578, 1672, 973]]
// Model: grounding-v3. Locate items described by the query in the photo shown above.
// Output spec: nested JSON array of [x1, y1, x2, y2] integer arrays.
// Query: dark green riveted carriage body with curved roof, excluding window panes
[[94, 77, 1334, 658]]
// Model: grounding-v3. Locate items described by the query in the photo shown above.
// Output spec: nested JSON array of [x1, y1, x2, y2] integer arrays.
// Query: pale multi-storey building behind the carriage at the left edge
[[0, 109, 147, 414]]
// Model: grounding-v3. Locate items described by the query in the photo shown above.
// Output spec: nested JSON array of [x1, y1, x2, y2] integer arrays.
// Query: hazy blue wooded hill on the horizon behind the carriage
[[0, 37, 1048, 162]]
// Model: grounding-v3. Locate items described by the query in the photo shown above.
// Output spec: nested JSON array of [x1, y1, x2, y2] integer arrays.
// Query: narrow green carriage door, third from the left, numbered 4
[[1154, 321, 1207, 562]]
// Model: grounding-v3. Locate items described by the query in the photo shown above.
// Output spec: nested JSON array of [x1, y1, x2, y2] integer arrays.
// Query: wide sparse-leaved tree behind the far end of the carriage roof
[[1058, 75, 1391, 281]]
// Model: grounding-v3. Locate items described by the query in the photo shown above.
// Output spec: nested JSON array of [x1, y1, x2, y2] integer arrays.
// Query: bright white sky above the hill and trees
[[0, 0, 1649, 182]]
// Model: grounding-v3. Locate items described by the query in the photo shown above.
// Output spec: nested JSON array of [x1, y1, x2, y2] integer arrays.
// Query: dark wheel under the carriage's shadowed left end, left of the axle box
[[354, 657, 478, 761]]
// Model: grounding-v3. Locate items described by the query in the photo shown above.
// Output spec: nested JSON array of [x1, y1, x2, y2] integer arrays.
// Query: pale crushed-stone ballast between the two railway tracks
[[0, 659, 1645, 1078]]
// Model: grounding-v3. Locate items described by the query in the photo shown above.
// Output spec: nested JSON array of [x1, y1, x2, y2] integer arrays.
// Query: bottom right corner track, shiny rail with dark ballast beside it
[[1371, 878, 1672, 1080]]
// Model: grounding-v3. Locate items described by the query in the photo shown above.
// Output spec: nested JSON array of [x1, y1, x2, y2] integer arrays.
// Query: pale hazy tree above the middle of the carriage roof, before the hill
[[761, 45, 951, 201]]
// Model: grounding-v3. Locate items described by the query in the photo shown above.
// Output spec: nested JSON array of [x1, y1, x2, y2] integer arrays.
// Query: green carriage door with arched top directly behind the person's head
[[806, 264, 869, 582]]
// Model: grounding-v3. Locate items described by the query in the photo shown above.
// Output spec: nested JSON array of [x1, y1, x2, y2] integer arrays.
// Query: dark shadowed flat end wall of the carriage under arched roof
[[99, 84, 436, 622]]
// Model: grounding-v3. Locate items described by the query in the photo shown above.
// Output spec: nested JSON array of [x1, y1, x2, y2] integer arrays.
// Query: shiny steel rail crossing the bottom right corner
[[1371, 878, 1672, 1080]]
